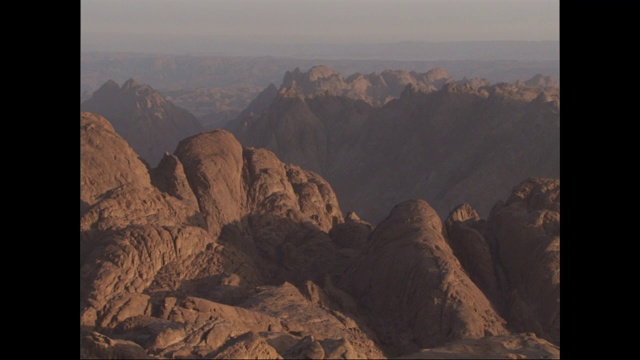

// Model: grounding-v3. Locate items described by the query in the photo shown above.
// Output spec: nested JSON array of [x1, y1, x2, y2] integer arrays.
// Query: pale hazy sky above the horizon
[[81, 0, 559, 43]]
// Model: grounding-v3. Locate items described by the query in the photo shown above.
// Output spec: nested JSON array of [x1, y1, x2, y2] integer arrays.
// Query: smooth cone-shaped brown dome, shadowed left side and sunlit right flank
[[341, 201, 507, 352]]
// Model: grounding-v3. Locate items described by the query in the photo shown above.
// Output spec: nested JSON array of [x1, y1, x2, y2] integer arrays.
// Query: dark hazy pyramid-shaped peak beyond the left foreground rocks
[[80, 79, 202, 166]]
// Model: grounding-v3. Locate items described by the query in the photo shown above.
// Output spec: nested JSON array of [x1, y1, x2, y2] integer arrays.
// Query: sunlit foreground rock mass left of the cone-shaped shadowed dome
[[81, 114, 383, 358]]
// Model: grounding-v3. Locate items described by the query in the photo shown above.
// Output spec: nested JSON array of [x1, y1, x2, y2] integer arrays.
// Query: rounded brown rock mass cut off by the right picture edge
[[489, 179, 560, 344]]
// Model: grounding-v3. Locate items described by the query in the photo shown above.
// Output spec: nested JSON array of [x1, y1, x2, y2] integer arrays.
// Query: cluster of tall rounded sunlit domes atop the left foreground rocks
[[170, 130, 342, 236]]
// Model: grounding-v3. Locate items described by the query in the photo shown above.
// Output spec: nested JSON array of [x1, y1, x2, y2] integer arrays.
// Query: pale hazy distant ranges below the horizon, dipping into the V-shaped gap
[[80, 52, 560, 138]]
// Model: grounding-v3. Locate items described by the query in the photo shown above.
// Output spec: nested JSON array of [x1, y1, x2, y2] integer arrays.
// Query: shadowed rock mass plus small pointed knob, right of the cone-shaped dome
[[446, 178, 560, 345]]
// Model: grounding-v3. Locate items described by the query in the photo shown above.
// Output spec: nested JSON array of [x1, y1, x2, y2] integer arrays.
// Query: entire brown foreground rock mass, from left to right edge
[[80, 113, 559, 359]]
